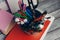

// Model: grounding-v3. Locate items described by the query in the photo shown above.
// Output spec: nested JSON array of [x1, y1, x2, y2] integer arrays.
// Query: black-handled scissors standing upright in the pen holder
[[27, 0, 39, 19]]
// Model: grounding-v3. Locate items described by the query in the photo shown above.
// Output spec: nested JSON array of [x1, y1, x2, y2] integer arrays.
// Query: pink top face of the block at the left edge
[[0, 10, 13, 34]]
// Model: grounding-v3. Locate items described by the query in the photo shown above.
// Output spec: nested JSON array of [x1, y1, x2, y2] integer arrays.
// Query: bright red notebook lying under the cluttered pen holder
[[5, 20, 50, 40]]
